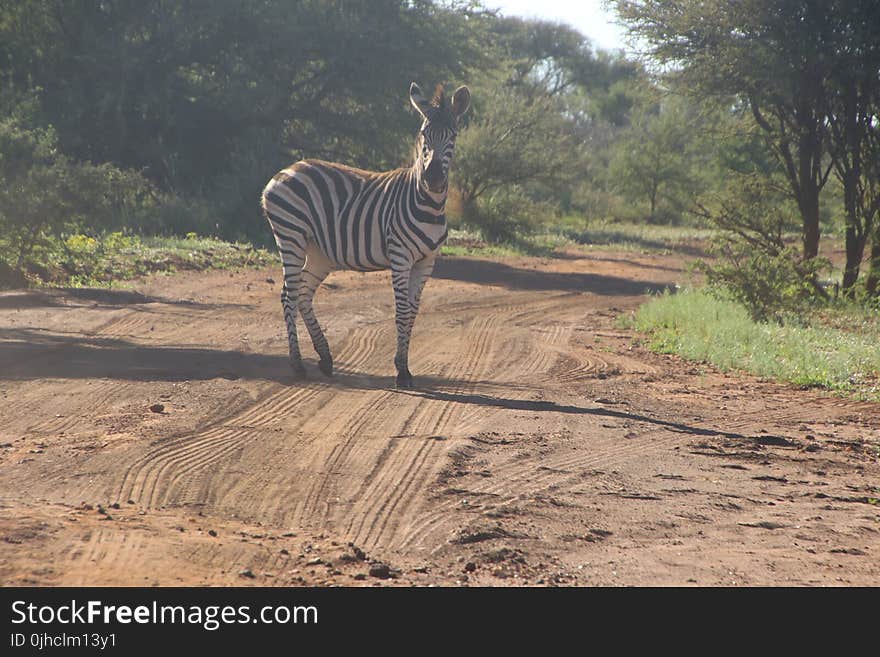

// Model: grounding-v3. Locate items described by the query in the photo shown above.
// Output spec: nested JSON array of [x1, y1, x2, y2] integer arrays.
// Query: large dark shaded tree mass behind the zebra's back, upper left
[[0, 0, 483, 237]]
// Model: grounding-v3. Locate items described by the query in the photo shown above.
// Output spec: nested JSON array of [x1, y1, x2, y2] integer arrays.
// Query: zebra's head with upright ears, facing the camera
[[409, 82, 471, 194]]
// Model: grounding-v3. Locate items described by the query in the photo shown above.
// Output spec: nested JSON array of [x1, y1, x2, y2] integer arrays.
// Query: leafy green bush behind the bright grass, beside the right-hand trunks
[[697, 176, 830, 322]]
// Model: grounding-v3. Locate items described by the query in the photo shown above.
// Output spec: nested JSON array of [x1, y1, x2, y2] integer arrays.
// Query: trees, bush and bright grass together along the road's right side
[[615, 0, 880, 400]]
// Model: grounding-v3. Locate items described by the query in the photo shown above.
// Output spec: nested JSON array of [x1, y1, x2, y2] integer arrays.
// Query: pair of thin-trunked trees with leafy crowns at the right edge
[[616, 0, 880, 284]]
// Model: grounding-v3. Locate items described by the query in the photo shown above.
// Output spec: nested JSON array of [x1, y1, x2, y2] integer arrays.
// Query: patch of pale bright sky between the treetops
[[483, 0, 627, 50]]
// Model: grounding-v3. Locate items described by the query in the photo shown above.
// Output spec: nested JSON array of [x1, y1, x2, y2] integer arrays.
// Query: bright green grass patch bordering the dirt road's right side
[[626, 290, 880, 401]]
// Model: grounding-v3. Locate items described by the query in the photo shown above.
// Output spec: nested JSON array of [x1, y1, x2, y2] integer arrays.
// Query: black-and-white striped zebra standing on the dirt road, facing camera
[[262, 82, 471, 388]]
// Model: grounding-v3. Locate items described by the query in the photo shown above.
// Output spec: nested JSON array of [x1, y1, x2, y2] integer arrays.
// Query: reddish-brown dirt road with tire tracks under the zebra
[[0, 252, 880, 586]]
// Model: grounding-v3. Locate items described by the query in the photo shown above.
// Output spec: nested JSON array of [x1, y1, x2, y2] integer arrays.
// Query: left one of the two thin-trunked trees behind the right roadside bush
[[617, 0, 830, 258]]
